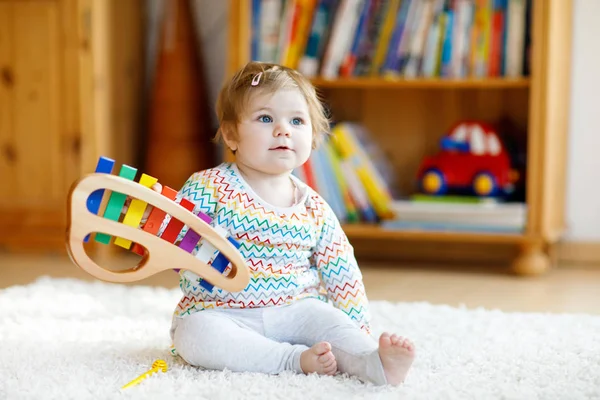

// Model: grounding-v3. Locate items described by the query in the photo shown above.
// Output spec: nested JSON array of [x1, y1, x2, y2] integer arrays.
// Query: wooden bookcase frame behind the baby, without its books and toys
[[225, 0, 572, 275]]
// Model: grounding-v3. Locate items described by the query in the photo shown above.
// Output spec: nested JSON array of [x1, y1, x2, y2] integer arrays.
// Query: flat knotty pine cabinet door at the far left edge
[[0, 1, 74, 249]]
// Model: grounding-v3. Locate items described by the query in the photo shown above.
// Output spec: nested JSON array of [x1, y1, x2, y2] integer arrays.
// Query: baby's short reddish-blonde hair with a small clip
[[215, 61, 329, 148]]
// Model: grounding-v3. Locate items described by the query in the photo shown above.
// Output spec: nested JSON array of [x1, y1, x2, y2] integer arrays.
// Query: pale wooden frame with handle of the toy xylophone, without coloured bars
[[67, 173, 250, 292]]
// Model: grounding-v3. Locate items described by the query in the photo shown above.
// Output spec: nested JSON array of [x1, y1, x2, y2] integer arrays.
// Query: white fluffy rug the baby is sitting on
[[0, 278, 600, 400]]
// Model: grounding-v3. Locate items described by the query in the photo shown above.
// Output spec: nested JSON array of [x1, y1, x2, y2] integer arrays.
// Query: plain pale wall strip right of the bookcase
[[566, 0, 600, 241]]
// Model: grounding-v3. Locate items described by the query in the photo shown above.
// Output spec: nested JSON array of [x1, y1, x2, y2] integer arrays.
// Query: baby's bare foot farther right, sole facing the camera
[[379, 332, 415, 386]]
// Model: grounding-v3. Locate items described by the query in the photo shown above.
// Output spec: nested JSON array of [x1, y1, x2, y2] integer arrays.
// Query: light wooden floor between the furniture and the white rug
[[0, 253, 600, 314]]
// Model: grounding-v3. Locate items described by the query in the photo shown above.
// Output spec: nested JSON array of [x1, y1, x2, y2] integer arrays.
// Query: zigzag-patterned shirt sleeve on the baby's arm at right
[[313, 201, 371, 333]]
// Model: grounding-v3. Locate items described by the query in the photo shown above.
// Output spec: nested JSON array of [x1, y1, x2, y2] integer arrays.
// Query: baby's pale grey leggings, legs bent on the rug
[[171, 299, 386, 385]]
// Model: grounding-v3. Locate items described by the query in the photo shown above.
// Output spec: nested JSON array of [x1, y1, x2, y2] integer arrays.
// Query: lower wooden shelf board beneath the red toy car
[[343, 224, 528, 244]]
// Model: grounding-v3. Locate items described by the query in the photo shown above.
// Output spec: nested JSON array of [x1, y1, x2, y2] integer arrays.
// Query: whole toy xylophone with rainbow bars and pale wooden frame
[[67, 157, 250, 292]]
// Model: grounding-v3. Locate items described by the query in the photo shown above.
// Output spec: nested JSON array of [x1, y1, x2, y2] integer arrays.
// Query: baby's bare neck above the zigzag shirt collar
[[236, 163, 296, 207]]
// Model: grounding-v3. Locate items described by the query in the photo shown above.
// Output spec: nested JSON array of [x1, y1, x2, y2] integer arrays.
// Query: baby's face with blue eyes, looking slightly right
[[225, 88, 312, 175]]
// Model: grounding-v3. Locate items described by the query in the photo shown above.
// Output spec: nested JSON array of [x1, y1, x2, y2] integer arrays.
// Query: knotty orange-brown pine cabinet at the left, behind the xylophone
[[0, 0, 144, 251]]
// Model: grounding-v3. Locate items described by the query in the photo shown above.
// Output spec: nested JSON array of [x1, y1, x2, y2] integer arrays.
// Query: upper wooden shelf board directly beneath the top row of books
[[311, 77, 530, 89]]
